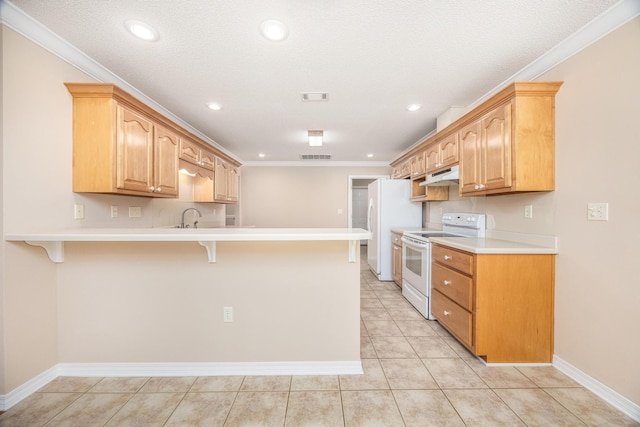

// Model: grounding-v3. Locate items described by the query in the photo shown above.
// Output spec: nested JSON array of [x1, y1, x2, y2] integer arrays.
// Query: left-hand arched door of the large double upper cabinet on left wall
[[116, 105, 153, 193]]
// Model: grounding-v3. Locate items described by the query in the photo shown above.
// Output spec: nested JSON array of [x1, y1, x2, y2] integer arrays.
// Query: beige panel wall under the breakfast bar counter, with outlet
[[58, 241, 360, 363]]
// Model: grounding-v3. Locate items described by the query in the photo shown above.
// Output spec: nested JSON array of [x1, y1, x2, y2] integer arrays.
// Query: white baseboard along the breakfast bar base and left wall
[[0, 360, 363, 411]]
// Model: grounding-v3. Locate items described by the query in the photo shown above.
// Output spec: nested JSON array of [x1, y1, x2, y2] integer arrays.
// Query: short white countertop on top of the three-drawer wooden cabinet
[[429, 237, 558, 254]]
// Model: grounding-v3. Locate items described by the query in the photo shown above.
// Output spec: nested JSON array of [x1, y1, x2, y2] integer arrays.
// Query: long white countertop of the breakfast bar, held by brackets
[[4, 227, 371, 242]]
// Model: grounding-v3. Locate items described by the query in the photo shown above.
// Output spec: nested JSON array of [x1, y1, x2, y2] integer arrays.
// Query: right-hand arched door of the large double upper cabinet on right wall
[[482, 104, 511, 189]]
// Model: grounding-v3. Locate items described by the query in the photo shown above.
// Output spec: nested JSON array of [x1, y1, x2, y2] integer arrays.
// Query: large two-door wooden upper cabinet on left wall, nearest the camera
[[67, 84, 179, 197]]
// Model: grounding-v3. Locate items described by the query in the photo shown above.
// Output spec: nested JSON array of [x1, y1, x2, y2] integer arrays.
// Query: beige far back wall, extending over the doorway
[[241, 166, 391, 227]]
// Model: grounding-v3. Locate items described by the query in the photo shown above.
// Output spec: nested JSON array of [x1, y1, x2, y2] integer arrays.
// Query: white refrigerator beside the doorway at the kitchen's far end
[[367, 179, 422, 281]]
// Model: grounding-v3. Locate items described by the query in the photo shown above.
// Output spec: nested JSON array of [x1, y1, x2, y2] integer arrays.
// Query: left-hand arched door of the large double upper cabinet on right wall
[[459, 122, 482, 194]]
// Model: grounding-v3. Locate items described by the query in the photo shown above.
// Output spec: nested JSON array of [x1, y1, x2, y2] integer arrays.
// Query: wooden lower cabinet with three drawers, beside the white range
[[431, 244, 555, 363]]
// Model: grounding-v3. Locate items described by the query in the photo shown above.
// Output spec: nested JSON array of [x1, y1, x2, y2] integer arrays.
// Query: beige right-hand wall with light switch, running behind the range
[[428, 18, 640, 404]]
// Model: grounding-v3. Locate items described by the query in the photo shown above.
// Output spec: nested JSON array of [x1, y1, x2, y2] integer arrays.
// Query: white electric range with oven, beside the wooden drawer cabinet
[[402, 213, 486, 319]]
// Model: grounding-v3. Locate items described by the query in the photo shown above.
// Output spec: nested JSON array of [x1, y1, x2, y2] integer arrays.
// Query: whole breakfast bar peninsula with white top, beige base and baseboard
[[5, 228, 370, 376]]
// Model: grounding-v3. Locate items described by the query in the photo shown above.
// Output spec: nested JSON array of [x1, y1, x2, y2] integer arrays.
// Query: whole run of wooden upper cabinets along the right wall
[[391, 82, 562, 196]]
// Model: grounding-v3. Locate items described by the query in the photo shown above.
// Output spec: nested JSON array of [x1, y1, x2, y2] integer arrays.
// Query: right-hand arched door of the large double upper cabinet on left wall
[[153, 126, 180, 196]]
